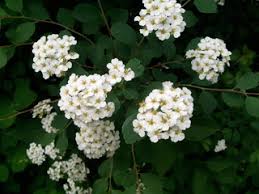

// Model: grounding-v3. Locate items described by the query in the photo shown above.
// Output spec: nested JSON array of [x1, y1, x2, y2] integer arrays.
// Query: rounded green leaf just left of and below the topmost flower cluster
[[111, 22, 137, 45]]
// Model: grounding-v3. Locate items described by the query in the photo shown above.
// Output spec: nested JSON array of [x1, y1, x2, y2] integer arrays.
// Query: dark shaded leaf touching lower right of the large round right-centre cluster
[[185, 118, 220, 141]]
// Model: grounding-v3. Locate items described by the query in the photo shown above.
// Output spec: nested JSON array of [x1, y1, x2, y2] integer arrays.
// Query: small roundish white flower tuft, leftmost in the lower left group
[[26, 143, 46, 166]]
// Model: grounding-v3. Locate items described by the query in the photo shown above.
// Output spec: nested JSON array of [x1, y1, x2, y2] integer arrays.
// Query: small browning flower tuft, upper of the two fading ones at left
[[32, 99, 53, 119]]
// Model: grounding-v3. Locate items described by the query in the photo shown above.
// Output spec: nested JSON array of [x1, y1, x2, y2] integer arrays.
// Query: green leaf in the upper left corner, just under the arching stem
[[6, 22, 35, 43]]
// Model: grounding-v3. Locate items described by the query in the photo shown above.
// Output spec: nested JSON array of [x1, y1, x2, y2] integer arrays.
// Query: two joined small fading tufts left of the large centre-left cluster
[[32, 99, 58, 133]]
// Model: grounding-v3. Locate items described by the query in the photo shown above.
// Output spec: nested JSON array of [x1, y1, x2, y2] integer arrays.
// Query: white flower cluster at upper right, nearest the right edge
[[186, 37, 231, 83]]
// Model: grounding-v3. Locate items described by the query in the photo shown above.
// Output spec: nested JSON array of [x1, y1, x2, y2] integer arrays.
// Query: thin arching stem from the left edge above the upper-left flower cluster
[[0, 16, 94, 45]]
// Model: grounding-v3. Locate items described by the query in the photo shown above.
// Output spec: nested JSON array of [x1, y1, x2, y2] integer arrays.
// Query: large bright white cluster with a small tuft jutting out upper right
[[58, 59, 135, 128]]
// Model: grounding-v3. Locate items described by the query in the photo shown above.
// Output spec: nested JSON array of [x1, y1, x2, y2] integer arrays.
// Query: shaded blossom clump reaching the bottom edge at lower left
[[47, 154, 92, 194]]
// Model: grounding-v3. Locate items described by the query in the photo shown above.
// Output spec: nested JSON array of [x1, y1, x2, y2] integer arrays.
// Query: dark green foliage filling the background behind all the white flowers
[[0, 0, 259, 194]]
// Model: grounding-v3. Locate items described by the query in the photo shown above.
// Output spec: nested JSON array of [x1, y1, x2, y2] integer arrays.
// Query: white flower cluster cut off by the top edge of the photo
[[134, 0, 186, 41]]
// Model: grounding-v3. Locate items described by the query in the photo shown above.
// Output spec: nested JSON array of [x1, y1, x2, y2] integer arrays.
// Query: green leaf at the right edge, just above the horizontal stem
[[236, 72, 259, 90]]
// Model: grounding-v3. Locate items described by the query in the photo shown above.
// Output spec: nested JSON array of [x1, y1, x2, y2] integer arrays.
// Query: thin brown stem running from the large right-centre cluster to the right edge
[[178, 84, 259, 96]]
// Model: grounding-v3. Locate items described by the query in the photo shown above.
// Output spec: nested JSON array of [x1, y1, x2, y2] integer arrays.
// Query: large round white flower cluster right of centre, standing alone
[[133, 81, 193, 142]]
